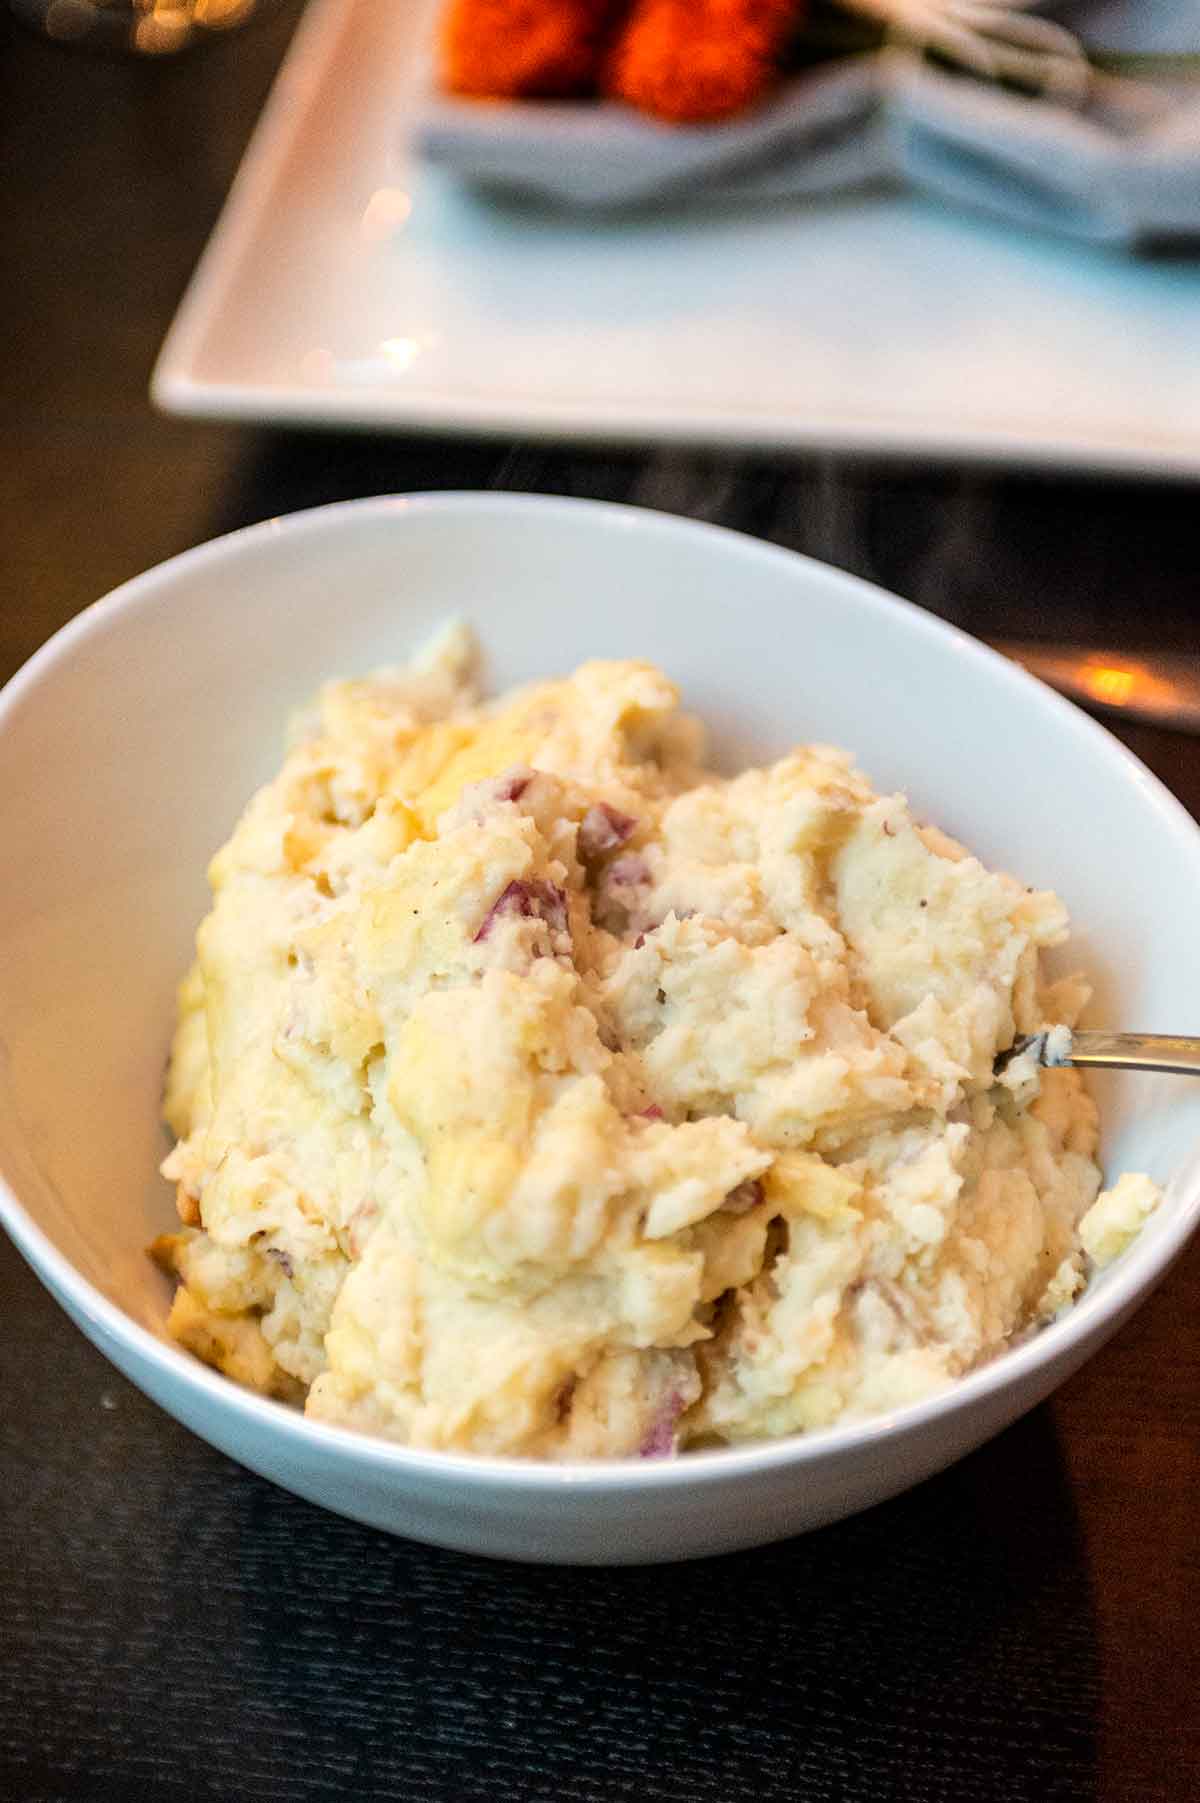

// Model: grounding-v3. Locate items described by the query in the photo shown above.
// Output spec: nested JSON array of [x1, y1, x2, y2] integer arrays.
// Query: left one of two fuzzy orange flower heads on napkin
[[441, 0, 629, 99]]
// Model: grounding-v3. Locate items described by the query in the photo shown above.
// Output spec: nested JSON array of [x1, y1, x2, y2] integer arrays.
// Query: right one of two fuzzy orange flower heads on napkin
[[605, 0, 805, 124]]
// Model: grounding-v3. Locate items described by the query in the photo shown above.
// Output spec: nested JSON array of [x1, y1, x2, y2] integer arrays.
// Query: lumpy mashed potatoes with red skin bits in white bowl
[[155, 629, 1155, 1459]]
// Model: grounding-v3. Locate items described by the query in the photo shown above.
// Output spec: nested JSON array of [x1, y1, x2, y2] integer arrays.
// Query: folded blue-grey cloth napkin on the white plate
[[418, 0, 1200, 245]]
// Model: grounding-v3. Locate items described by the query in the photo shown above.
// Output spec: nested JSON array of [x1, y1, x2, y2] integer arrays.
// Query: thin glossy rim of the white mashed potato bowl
[[0, 489, 1200, 1495]]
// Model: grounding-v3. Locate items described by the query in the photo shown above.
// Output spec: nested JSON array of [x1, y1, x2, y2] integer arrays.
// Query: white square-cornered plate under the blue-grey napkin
[[153, 0, 1200, 474]]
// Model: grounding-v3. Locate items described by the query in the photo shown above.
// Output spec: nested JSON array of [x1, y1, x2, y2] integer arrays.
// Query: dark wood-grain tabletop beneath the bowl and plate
[[0, 0, 1200, 1803]]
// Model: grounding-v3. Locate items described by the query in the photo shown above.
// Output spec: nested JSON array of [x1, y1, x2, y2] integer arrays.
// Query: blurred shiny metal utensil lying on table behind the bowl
[[993, 640, 1200, 732]]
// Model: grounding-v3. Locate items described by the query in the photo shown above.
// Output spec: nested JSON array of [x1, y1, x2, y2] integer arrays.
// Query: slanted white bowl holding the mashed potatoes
[[0, 494, 1200, 1563]]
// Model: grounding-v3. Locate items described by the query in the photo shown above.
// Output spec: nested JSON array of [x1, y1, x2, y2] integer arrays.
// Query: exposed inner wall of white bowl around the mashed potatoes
[[0, 496, 1200, 1363]]
